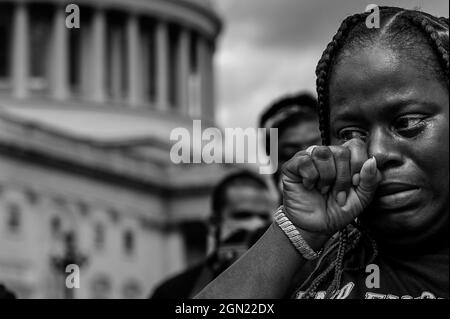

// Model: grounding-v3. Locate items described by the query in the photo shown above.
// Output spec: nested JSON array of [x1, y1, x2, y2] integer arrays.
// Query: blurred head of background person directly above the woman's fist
[[259, 92, 321, 198]]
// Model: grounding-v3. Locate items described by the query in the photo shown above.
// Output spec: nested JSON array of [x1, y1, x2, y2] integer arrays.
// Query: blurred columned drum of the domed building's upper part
[[0, 0, 221, 119]]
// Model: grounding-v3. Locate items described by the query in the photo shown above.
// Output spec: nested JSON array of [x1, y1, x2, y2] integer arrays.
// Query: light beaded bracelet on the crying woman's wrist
[[274, 206, 322, 260]]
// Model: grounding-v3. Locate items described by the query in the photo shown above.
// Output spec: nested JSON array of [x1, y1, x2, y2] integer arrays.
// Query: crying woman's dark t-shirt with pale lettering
[[293, 230, 449, 299]]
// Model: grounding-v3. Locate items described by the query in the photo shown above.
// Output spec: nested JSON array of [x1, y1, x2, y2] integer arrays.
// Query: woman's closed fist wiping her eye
[[282, 139, 381, 236]]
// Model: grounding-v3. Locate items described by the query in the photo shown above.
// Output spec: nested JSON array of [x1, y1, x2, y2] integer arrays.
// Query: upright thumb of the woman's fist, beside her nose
[[355, 157, 381, 208]]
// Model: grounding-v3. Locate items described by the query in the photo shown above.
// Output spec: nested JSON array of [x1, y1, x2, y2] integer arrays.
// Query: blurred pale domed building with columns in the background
[[0, 0, 227, 298]]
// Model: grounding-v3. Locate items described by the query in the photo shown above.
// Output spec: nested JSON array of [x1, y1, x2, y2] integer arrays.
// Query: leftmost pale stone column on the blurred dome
[[12, 2, 30, 98]]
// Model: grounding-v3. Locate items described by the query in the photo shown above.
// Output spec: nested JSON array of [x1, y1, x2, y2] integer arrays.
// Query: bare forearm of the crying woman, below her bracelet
[[195, 224, 327, 299]]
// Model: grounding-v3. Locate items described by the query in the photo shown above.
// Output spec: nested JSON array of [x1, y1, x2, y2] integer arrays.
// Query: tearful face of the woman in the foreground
[[330, 45, 449, 244]]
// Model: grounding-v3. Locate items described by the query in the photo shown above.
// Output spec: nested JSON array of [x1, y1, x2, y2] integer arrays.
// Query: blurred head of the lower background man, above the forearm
[[210, 170, 276, 249]]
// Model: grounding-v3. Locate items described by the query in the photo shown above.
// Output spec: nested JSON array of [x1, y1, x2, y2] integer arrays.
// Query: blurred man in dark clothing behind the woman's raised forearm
[[151, 171, 276, 299]]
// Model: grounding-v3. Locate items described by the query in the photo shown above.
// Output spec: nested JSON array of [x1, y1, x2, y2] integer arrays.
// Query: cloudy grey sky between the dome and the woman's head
[[215, 0, 449, 128]]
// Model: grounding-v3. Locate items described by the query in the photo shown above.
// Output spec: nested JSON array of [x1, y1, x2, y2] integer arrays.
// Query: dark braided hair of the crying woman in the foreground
[[301, 7, 449, 299]]
